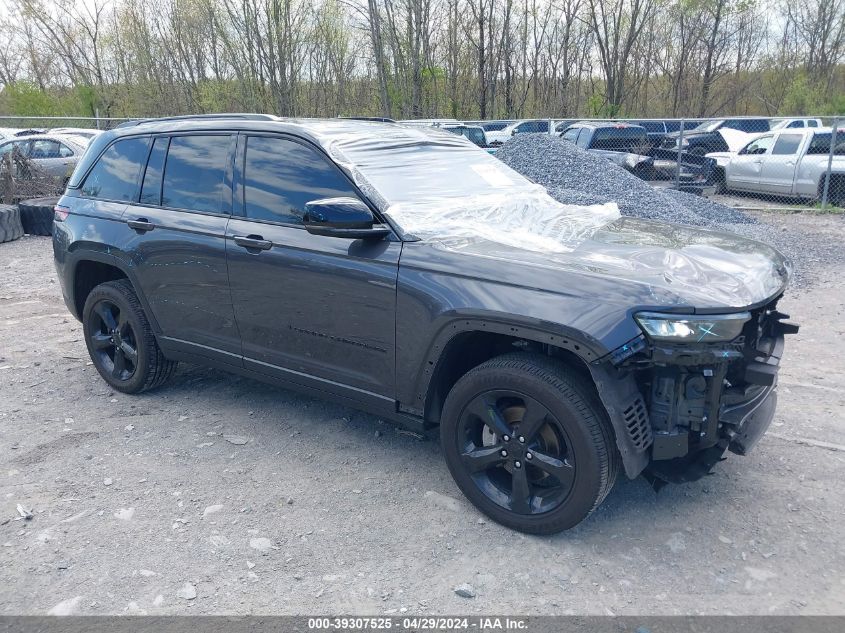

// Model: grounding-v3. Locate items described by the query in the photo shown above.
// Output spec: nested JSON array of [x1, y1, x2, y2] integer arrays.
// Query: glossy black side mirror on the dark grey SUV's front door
[[303, 198, 390, 240]]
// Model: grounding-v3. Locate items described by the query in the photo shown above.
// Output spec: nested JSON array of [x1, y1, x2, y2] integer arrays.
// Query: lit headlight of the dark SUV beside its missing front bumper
[[634, 312, 751, 343]]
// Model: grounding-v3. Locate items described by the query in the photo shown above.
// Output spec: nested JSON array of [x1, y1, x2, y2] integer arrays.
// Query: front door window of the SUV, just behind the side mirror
[[244, 136, 358, 224]]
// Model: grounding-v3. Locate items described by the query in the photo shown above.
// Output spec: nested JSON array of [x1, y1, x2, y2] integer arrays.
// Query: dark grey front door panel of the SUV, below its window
[[227, 218, 401, 398]]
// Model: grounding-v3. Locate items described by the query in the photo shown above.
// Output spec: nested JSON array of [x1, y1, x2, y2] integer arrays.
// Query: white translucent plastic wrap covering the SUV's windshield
[[304, 121, 620, 252]]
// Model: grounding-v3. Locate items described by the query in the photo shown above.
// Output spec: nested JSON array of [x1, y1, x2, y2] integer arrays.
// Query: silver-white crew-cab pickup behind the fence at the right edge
[[707, 128, 845, 204]]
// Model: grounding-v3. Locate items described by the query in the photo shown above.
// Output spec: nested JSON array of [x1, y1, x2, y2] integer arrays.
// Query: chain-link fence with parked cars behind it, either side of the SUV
[[0, 116, 845, 211]]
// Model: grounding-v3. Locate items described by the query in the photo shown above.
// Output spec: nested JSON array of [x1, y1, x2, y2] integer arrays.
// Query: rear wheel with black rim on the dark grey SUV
[[82, 279, 176, 393]]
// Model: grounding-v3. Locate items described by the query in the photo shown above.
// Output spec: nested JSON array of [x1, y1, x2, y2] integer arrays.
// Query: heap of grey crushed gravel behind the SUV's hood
[[496, 134, 755, 227]]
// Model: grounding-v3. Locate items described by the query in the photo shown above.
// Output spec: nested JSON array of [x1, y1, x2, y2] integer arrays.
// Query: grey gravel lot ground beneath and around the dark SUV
[[0, 211, 845, 614]]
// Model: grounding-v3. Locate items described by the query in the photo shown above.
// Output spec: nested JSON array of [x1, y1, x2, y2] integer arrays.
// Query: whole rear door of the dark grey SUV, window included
[[123, 132, 241, 356]]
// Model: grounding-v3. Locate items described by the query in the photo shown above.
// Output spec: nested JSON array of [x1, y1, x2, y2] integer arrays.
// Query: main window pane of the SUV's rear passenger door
[[161, 135, 232, 213]]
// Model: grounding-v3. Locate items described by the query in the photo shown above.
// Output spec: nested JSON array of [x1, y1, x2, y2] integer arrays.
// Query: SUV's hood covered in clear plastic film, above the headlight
[[432, 217, 792, 311]]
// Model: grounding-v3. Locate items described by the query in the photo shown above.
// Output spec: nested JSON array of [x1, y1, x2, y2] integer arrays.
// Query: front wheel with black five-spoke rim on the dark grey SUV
[[440, 353, 619, 534]]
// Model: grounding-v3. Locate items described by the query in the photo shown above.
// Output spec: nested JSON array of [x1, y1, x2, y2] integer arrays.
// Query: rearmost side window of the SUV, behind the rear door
[[82, 136, 150, 201]]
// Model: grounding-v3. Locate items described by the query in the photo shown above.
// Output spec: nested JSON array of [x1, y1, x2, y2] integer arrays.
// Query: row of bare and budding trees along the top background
[[0, 0, 845, 119]]
